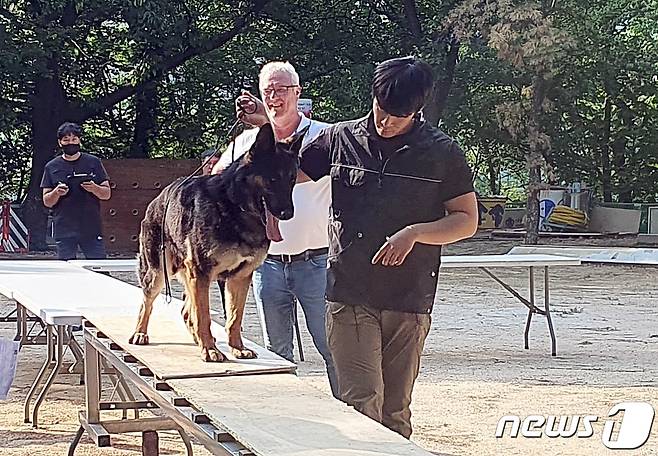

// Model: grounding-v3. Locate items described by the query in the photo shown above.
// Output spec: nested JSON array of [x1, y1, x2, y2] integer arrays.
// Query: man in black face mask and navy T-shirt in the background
[[41, 122, 111, 260]]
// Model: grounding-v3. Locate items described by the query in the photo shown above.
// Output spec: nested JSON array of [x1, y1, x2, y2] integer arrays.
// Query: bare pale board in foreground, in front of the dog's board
[[168, 374, 431, 456]]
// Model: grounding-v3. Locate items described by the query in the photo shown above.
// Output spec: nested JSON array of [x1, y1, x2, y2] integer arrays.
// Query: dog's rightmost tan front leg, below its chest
[[225, 274, 256, 359]]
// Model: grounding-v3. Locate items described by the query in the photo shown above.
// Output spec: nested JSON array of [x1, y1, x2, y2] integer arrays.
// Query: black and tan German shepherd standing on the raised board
[[129, 124, 301, 362]]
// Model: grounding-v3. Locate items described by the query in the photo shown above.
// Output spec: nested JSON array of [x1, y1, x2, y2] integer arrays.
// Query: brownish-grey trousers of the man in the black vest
[[326, 302, 431, 438]]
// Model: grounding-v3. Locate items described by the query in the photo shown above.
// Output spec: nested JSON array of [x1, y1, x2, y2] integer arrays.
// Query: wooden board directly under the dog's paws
[[81, 305, 295, 380]]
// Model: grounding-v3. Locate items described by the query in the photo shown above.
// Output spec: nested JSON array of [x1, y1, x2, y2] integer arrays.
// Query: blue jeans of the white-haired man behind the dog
[[253, 254, 338, 397]]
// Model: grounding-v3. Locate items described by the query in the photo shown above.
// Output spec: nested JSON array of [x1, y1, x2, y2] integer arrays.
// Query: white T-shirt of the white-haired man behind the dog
[[219, 114, 331, 255]]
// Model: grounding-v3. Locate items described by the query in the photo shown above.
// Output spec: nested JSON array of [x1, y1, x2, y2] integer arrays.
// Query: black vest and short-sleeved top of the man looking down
[[327, 118, 473, 313]]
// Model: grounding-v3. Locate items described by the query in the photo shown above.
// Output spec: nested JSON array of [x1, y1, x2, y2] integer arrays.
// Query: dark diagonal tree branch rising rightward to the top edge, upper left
[[78, 0, 270, 122]]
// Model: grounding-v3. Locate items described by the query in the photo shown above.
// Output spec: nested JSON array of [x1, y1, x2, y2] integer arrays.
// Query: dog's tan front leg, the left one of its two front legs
[[181, 260, 226, 362]]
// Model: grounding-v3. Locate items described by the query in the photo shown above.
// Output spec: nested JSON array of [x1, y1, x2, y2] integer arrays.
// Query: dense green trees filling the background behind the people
[[0, 0, 658, 205]]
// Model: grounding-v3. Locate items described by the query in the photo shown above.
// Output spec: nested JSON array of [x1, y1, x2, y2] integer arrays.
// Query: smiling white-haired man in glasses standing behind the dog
[[213, 62, 338, 397]]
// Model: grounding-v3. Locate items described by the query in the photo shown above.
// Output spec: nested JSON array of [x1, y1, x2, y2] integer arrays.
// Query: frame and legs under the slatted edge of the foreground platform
[[69, 322, 253, 456]]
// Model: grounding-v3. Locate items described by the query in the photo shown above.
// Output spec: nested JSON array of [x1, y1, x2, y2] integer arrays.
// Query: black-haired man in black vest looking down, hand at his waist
[[299, 57, 478, 438]]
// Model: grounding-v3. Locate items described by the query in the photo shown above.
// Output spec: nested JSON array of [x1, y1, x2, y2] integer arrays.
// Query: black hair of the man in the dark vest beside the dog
[[372, 57, 434, 117]]
